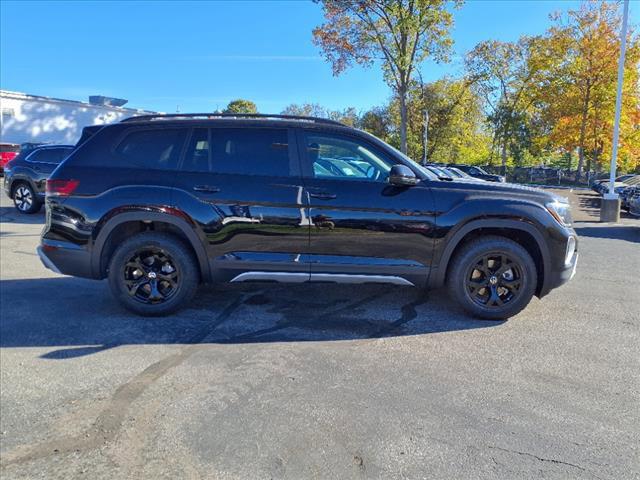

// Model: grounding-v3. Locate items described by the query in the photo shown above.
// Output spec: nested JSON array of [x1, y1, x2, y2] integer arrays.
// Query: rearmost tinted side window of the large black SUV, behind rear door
[[117, 128, 187, 170]]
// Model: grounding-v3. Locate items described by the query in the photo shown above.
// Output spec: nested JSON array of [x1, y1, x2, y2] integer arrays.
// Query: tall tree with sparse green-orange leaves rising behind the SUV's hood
[[313, 0, 462, 153]]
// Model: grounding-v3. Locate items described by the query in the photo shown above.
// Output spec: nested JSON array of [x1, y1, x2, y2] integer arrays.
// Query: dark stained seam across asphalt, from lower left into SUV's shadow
[[0, 296, 245, 468]]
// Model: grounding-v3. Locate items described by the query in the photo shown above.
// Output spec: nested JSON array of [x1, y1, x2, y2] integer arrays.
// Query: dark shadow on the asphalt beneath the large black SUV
[[0, 277, 502, 359]]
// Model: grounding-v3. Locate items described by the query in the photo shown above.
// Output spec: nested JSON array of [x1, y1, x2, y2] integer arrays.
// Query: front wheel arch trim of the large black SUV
[[430, 219, 551, 295]]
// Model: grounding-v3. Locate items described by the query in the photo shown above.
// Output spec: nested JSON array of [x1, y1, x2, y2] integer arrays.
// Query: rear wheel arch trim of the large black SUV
[[91, 211, 211, 282]]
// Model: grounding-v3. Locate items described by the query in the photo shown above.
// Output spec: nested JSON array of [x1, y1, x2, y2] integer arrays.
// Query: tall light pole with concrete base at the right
[[600, 0, 629, 222]]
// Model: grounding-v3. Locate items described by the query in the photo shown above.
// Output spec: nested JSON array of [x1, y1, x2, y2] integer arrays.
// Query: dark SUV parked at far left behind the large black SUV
[[4, 145, 74, 213]]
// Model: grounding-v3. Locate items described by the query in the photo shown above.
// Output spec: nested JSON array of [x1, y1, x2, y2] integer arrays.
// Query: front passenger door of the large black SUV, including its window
[[300, 129, 435, 285]]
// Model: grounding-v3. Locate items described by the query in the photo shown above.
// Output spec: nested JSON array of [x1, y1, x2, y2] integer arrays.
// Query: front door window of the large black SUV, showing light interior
[[305, 133, 393, 182]]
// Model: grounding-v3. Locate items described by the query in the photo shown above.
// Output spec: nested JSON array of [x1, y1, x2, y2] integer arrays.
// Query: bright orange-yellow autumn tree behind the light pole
[[542, 1, 640, 178]]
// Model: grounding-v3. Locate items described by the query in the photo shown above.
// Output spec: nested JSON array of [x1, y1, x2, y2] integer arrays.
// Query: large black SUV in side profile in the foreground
[[38, 114, 578, 319]]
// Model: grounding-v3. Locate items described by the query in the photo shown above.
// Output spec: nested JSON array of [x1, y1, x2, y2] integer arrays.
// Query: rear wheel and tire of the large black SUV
[[108, 232, 200, 317]]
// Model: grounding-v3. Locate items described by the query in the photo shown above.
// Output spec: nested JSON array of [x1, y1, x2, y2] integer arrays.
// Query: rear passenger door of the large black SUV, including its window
[[174, 127, 309, 281]]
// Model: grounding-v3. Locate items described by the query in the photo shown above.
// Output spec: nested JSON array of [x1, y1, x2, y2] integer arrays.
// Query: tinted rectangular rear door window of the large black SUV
[[210, 128, 291, 177]]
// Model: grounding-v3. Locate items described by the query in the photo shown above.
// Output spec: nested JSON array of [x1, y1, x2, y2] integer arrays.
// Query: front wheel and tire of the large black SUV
[[447, 236, 538, 320]]
